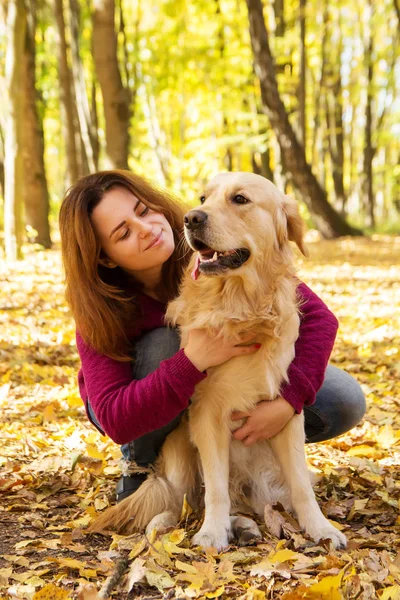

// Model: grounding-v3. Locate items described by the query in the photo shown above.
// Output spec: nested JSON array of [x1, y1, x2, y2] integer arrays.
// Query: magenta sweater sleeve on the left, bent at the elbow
[[76, 333, 206, 444]]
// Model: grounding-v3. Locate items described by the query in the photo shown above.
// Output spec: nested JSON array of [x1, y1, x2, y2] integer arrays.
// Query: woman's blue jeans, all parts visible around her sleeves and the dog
[[89, 327, 366, 466]]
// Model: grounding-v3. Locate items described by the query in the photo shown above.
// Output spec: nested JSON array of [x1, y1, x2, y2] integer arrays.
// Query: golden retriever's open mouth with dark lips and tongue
[[191, 240, 250, 279]]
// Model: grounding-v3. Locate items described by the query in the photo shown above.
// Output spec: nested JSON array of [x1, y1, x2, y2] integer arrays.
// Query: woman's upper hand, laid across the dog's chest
[[184, 329, 261, 371]]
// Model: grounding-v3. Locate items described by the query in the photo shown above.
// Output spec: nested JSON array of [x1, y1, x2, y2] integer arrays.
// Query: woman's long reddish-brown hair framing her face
[[59, 170, 191, 361]]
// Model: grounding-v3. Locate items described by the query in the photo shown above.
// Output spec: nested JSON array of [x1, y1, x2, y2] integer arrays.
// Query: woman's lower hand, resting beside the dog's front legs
[[231, 396, 295, 446]]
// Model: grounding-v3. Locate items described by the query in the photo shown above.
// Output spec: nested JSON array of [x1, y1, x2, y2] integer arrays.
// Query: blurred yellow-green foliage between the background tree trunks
[[0, 0, 400, 228]]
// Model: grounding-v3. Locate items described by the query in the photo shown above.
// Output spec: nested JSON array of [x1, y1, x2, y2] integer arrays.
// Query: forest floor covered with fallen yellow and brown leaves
[[0, 236, 400, 600]]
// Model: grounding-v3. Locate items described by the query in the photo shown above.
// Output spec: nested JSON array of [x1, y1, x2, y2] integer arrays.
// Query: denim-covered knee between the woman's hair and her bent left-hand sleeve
[[133, 327, 180, 379]]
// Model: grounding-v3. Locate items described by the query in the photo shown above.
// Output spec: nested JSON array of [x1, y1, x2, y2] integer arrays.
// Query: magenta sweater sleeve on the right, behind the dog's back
[[281, 283, 339, 413]]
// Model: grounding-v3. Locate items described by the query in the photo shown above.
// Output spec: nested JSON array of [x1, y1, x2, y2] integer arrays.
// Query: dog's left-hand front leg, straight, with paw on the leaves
[[190, 408, 231, 550]]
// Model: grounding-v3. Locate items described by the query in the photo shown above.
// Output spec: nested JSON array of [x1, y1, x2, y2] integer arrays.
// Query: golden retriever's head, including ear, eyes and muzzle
[[185, 173, 306, 275]]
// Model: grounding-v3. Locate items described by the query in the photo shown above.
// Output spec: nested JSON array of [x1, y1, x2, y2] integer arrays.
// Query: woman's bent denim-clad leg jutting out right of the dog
[[304, 365, 366, 442]]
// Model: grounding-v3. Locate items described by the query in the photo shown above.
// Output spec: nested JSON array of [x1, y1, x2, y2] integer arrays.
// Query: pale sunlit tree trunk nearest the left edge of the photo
[[4, 0, 26, 260]]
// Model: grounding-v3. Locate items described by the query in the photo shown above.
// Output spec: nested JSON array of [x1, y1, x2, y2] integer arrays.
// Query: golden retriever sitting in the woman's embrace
[[92, 173, 346, 549]]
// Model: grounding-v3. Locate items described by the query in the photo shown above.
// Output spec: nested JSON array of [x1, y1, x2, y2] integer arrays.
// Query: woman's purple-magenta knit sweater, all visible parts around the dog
[[76, 283, 338, 444]]
